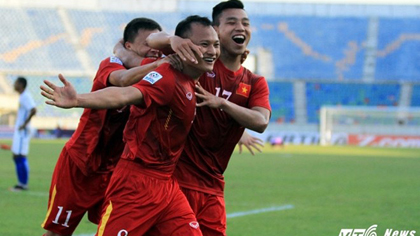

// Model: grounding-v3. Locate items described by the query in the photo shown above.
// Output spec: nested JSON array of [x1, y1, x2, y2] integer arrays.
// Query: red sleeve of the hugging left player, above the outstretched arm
[[93, 56, 126, 89]]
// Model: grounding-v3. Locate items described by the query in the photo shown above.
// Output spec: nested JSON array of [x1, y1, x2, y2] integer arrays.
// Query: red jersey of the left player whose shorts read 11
[[65, 57, 129, 175]]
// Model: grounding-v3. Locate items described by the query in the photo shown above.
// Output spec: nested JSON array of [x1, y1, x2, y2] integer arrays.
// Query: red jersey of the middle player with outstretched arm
[[121, 63, 196, 178]]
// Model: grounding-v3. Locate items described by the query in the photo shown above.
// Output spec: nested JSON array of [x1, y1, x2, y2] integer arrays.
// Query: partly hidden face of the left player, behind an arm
[[125, 29, 161, 58]]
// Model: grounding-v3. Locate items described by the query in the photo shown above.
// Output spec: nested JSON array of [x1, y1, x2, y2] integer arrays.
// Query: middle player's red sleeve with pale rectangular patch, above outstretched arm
[[133, 65, 175, 108]]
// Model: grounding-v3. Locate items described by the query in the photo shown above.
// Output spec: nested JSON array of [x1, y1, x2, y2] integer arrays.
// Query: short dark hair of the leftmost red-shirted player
[[124, 17, 162, 43]]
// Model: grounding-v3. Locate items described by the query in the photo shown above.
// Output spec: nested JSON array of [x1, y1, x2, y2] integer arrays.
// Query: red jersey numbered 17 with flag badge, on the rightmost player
[[174, 60, 271, 196]]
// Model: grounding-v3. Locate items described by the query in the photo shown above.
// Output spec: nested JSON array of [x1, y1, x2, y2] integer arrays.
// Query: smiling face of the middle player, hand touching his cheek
[[186, 23, 220, 72]]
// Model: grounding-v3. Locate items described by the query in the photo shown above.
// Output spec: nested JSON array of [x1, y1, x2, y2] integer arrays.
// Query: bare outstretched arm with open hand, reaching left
[[41, 74, 143, 109]]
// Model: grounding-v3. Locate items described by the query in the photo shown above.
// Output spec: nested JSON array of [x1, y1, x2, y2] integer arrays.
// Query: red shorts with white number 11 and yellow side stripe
[[42, 148, 111, 235]]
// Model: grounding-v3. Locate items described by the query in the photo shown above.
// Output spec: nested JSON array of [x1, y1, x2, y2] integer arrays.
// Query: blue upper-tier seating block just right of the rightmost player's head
[[250, 16, 367, 80]]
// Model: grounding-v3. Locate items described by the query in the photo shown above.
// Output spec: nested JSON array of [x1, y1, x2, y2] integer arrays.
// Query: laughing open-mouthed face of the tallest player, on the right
[[215, 9, 251, 55]]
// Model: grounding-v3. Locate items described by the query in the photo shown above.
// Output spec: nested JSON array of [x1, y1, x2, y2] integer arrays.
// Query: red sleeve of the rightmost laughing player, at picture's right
[[248, 77, 271, 111]]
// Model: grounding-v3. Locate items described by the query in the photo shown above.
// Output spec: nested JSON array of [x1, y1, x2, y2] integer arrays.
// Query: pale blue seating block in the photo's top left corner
[[0, 9, 81, 71]]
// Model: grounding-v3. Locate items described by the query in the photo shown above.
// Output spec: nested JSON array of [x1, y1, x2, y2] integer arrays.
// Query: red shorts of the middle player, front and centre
[[97, 159, 202, 236]]
